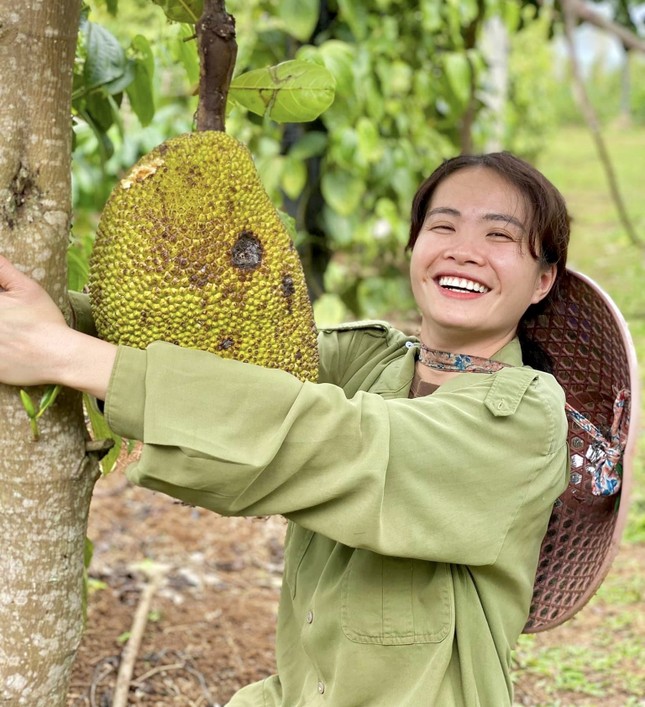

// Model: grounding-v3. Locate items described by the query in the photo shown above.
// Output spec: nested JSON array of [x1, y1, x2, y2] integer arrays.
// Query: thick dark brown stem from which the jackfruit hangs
[[195, 0, 237, 132]]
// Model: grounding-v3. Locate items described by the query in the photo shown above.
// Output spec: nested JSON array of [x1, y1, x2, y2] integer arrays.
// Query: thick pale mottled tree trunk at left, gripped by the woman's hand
[[0, 0, 97, 707]]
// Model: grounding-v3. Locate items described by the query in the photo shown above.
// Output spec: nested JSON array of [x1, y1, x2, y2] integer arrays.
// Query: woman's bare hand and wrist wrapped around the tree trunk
[[0, 255, 116, 398]]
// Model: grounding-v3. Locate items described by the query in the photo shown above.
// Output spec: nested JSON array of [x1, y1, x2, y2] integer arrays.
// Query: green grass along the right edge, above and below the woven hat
[[514, 127, 645, 707]]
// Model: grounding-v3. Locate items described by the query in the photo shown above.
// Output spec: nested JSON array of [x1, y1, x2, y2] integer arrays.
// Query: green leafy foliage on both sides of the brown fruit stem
[[70, 0, 572, 319]]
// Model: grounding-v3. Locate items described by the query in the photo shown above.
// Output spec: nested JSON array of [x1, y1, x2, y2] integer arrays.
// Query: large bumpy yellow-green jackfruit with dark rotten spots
[[89, 131, 318, 388]]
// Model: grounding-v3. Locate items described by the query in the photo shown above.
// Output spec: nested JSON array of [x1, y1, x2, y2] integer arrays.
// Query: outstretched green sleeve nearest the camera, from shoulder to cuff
[[106, 343, 567, 564]]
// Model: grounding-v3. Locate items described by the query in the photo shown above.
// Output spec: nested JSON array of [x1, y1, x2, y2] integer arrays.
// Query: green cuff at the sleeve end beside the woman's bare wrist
[[105, 346, 147, 440]]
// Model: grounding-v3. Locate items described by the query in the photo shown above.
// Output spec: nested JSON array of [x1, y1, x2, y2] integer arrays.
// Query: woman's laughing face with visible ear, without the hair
[[410, 167, 556, 356]]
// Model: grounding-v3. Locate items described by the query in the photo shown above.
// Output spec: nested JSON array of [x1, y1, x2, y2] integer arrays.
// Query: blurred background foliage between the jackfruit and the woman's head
[[221, 0, 564, 322]]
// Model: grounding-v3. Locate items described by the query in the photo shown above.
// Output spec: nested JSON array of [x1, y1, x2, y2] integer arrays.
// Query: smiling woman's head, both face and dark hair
[[408, 153, 570, 378]]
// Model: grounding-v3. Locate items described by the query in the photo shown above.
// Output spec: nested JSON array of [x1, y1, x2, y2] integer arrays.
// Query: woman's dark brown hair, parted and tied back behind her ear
[[406, 152, 571, 370]]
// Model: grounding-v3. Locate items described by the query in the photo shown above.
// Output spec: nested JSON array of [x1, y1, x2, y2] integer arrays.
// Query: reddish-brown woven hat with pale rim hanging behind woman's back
[[524, 270, 639, 633]]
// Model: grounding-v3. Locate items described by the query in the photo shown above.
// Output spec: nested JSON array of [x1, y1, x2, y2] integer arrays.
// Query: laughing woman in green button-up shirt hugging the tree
[[0, 153, 569, 707]]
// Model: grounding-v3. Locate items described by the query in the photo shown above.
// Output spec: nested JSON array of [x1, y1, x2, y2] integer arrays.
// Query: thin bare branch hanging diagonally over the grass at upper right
[[560, 0, 643, 247]]
